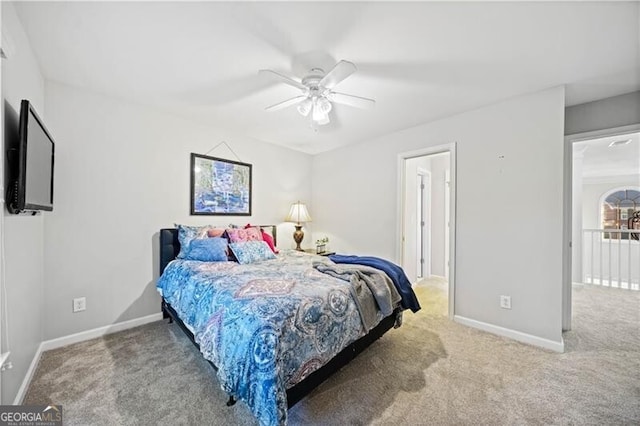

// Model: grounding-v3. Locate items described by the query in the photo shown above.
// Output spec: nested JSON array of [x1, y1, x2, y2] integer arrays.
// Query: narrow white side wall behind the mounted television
[[1, 2, 48, 404]]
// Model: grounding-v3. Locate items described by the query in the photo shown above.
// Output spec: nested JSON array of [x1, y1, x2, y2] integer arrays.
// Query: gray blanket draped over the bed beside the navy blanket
[[313, 262, 401, 332]]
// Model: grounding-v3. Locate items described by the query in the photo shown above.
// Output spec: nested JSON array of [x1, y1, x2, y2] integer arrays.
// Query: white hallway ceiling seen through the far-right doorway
[[573, 132, 640, 181]]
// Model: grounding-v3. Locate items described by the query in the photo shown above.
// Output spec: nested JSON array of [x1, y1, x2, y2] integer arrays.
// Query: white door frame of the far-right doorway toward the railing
[[562, 124, 640, 331]]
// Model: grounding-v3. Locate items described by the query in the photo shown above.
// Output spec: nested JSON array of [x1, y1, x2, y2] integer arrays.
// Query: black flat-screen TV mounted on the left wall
[[7, 100, 55, 213]]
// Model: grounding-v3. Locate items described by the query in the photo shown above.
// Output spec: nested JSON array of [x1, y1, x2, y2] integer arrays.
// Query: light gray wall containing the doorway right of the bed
[[312, 88, 564, 344]]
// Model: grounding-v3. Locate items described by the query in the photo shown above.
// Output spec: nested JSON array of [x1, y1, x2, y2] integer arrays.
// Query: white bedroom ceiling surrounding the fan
[[11, 2, 640, 153]]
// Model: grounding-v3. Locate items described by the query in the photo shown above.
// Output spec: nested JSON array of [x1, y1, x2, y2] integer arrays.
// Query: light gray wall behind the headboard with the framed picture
[[44, 82, 313, 339]]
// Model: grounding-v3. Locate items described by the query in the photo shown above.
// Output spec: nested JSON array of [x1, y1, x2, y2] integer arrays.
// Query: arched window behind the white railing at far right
[[602, 189, 640, 241]]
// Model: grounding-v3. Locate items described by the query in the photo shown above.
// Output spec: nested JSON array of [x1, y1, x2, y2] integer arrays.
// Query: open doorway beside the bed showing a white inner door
[[398, 144, 455, 318]]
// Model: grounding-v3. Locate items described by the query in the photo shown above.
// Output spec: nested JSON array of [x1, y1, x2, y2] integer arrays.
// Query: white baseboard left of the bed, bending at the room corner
[[13, 312, 162, 405]]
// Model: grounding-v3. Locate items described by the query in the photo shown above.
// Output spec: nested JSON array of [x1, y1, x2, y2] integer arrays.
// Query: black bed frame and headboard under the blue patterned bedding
[[160, 228, 402, 407]]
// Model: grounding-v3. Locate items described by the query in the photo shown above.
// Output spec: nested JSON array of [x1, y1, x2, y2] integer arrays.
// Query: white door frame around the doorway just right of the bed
[[396, 142, 457, 320]]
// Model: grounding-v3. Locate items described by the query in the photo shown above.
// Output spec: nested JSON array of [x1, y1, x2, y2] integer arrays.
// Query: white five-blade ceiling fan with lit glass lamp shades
[[259, 61, 376, 126]]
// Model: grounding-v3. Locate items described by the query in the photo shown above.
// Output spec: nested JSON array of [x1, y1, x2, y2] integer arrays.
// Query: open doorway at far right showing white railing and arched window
[[563, 128, 640, 333]]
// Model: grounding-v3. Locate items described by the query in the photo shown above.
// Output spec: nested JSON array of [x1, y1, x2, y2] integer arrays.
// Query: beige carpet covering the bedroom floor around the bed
[[25, 281, 640, 425]]
